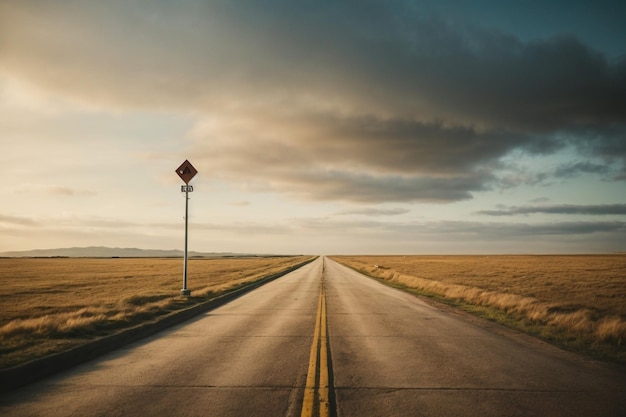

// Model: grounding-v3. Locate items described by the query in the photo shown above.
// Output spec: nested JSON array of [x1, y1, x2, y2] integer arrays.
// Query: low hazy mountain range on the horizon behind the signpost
[[0, 246, 253, 258]]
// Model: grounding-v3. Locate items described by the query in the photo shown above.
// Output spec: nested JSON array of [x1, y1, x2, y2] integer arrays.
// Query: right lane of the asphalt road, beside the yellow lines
[[325, 260, 626, 417]]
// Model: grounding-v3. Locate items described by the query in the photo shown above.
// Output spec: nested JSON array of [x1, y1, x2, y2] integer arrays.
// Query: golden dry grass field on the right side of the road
[[332, 254, 626, 363]]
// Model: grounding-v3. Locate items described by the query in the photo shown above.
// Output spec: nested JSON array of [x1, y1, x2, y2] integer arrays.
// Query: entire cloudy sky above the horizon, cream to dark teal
[[0, 0, 626, 254]]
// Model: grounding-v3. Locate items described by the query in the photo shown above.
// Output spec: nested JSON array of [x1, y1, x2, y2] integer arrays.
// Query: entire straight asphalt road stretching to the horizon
[[0, 258, 626, 417]]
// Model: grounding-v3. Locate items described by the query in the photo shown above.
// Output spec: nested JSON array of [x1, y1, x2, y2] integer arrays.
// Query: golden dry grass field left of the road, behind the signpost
[[0, 256, 310, 368]]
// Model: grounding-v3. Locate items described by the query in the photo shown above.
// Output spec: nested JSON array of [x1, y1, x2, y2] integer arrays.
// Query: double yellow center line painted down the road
[[301, 285, 330, 417]]
